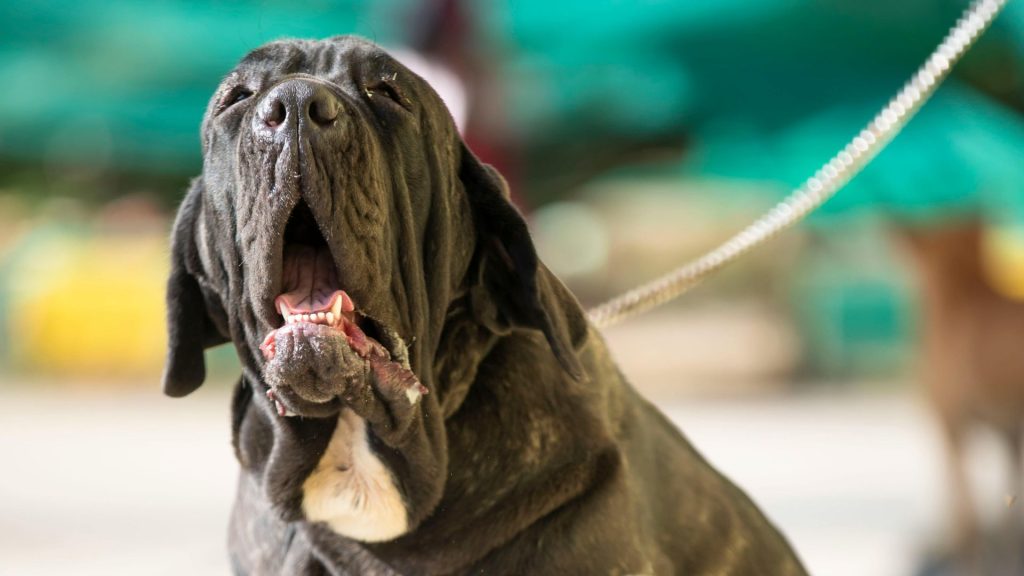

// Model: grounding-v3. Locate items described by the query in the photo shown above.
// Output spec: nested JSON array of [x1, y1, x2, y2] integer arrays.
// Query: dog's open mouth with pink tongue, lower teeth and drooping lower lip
[[260, 201, 409, 416]]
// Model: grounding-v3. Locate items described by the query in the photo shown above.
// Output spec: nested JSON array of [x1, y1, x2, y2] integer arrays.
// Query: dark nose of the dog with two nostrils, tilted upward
[[253, 78, 341, 133]]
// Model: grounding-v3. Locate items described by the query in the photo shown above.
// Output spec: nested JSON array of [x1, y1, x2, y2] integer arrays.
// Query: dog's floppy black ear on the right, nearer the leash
[[459, 145, 587, 380]]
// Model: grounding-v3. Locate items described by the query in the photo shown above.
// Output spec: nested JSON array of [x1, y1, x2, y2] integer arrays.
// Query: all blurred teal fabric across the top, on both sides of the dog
[[0, 0, 1024, 218]]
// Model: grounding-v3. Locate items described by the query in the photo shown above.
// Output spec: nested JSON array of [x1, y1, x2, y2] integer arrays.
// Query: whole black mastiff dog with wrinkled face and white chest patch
[[164, 37, 803, 575]]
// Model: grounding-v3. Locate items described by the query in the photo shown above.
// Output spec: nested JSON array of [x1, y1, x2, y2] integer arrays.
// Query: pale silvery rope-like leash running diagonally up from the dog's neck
[[588, 0, 1008, 328]]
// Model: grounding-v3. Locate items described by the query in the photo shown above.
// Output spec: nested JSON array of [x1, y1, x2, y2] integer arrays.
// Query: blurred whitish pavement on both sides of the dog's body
[[0, 382, 1002, 576]]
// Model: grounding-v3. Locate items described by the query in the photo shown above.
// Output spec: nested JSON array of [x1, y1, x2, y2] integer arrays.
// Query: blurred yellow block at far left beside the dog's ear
[[8, 228, 169, 377]]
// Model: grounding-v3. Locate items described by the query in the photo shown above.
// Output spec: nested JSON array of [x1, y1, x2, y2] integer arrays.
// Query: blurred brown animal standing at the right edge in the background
[[903, 221, 1024, 574]]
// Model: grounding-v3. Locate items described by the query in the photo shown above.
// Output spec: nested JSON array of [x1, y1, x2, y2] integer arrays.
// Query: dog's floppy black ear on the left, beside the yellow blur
[[164, 178, 227, 398]]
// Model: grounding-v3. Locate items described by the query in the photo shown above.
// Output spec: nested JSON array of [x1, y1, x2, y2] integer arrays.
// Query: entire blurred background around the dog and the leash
[[0, 0, 1024, 576]]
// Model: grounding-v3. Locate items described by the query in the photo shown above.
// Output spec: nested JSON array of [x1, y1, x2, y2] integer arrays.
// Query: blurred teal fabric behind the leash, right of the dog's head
[[486, 0, 1024, 221]]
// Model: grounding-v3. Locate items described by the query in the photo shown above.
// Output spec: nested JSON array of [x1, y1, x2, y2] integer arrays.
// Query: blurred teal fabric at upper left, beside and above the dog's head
[[0, 0, 409, 172]]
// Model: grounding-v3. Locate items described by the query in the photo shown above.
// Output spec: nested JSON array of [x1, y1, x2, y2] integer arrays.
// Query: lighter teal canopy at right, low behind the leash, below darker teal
[[683, 82, 1024, 219]]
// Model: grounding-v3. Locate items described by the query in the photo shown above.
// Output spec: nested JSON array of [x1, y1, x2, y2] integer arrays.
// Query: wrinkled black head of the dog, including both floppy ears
[[164, 37, 586, 416]]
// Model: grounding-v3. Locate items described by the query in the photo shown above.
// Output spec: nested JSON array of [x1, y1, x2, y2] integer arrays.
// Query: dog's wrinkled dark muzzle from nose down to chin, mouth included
[[239, 78, 410, 416]]
